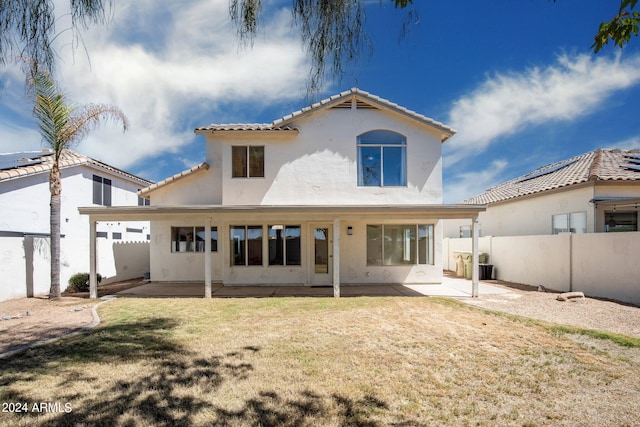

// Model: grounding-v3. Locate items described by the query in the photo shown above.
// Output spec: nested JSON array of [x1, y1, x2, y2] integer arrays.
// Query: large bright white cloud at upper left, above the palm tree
[[0, 0, 307, 169]]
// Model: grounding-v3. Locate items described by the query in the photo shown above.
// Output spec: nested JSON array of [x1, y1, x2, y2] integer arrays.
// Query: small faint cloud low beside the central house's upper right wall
[[444, 159, 509, 203]]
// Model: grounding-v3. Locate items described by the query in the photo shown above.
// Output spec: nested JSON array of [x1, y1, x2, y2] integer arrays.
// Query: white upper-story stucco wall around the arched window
[[198, 109, 442, 205]]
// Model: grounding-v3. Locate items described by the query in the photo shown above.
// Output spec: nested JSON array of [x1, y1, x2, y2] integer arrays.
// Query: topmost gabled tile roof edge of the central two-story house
[[195, 88, 456, 142]]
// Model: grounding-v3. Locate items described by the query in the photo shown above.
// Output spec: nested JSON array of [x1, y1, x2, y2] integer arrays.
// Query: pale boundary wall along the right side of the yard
[[442, 232, 640, 305]]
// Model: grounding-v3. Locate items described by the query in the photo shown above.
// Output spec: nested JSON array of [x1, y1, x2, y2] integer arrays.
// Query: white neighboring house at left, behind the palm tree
[[0, 149, 152, 241]]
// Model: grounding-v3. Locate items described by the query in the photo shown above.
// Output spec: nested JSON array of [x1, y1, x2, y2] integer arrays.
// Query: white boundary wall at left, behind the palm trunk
[[0, 236, 150, 301]]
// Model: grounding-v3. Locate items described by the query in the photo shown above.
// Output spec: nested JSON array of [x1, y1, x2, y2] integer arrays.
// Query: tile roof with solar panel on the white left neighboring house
[[0, 149, 152, 186]]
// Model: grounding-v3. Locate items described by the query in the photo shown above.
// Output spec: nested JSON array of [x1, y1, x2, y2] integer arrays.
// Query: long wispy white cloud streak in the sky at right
[[445, 55, 640, 166]]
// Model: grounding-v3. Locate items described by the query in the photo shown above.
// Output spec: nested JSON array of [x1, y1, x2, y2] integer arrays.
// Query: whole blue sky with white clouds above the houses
[[0, 0, 640, 203]]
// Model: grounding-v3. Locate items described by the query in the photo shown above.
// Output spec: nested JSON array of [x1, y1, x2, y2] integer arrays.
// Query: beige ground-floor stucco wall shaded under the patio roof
[[150, 216, 442, 285]]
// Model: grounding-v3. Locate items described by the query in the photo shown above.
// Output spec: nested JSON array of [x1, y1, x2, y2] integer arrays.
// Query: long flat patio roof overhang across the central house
[[78, 204, 486, 221]]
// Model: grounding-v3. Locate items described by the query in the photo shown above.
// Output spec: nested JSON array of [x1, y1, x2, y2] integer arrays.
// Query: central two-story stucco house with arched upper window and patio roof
[[81, 89, 484, 294]]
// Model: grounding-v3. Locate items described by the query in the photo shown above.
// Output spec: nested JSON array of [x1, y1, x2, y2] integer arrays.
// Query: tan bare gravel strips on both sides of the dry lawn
[[0, 282, 640, 354]]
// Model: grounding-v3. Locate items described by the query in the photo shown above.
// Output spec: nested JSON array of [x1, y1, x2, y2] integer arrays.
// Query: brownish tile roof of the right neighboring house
[[462, 149, 640, 204]]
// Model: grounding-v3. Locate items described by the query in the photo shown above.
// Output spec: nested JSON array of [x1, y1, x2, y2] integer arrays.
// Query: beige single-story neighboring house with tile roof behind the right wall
[[445, 149, 640, 237]]
